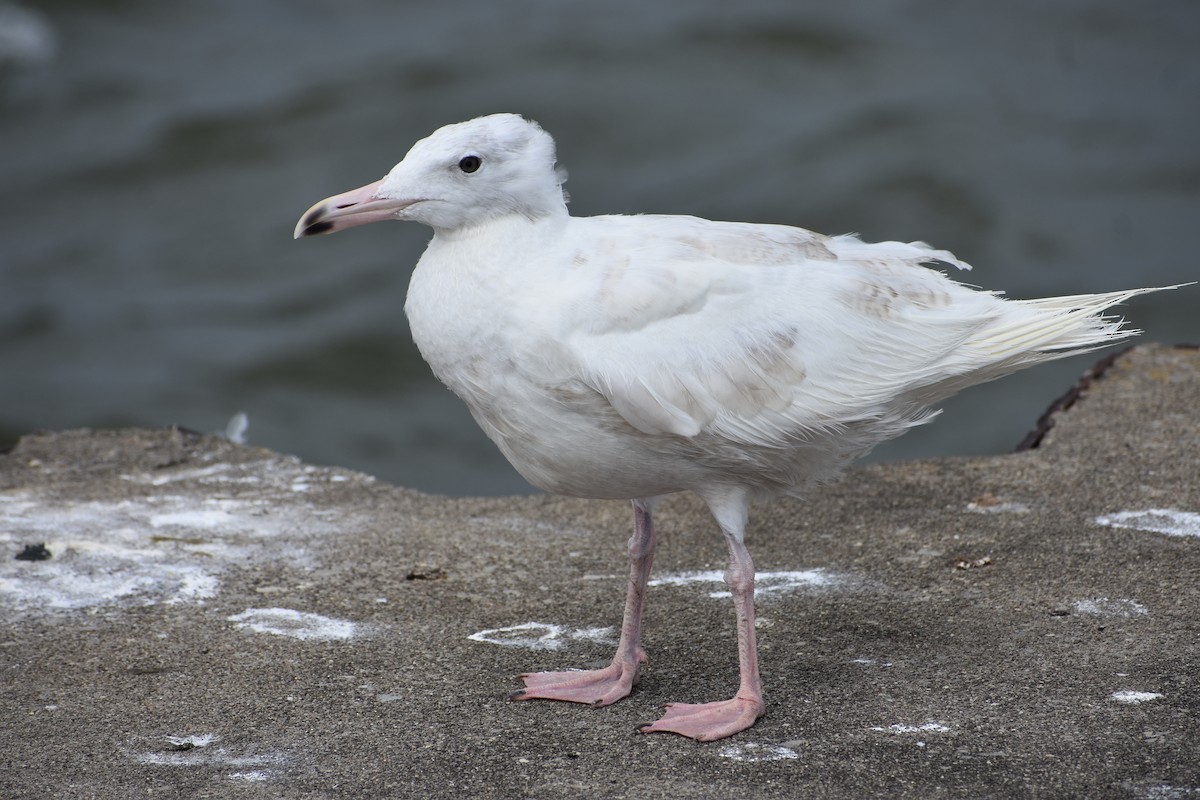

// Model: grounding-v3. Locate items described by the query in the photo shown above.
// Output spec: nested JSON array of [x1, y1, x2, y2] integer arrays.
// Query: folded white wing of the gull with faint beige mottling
[[556, 216, 988, 446]]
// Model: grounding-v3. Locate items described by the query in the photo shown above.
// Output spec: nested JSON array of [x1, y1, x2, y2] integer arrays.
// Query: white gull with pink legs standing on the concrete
[[295, 114, 1176, 740]]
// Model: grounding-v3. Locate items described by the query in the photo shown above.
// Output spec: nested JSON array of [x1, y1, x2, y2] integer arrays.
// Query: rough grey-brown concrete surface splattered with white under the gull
[[0, 347, 1200, 800]]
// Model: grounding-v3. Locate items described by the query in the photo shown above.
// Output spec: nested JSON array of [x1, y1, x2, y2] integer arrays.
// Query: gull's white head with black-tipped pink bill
[[295, 114, 565, 239]]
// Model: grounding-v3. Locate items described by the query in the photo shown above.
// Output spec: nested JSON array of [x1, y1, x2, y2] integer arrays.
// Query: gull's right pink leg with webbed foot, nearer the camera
[[638, 492, 766, 741]]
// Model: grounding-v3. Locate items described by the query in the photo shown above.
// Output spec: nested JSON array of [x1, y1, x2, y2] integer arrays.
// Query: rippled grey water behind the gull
[[0, 0, 1200, 493]]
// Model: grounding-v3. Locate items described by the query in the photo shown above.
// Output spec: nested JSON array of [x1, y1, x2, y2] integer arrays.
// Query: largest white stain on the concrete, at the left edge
[[0, 458, 355, 613]]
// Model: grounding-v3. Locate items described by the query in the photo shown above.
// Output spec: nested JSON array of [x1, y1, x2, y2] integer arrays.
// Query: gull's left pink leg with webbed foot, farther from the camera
[[512, 500, 655, 706]]
